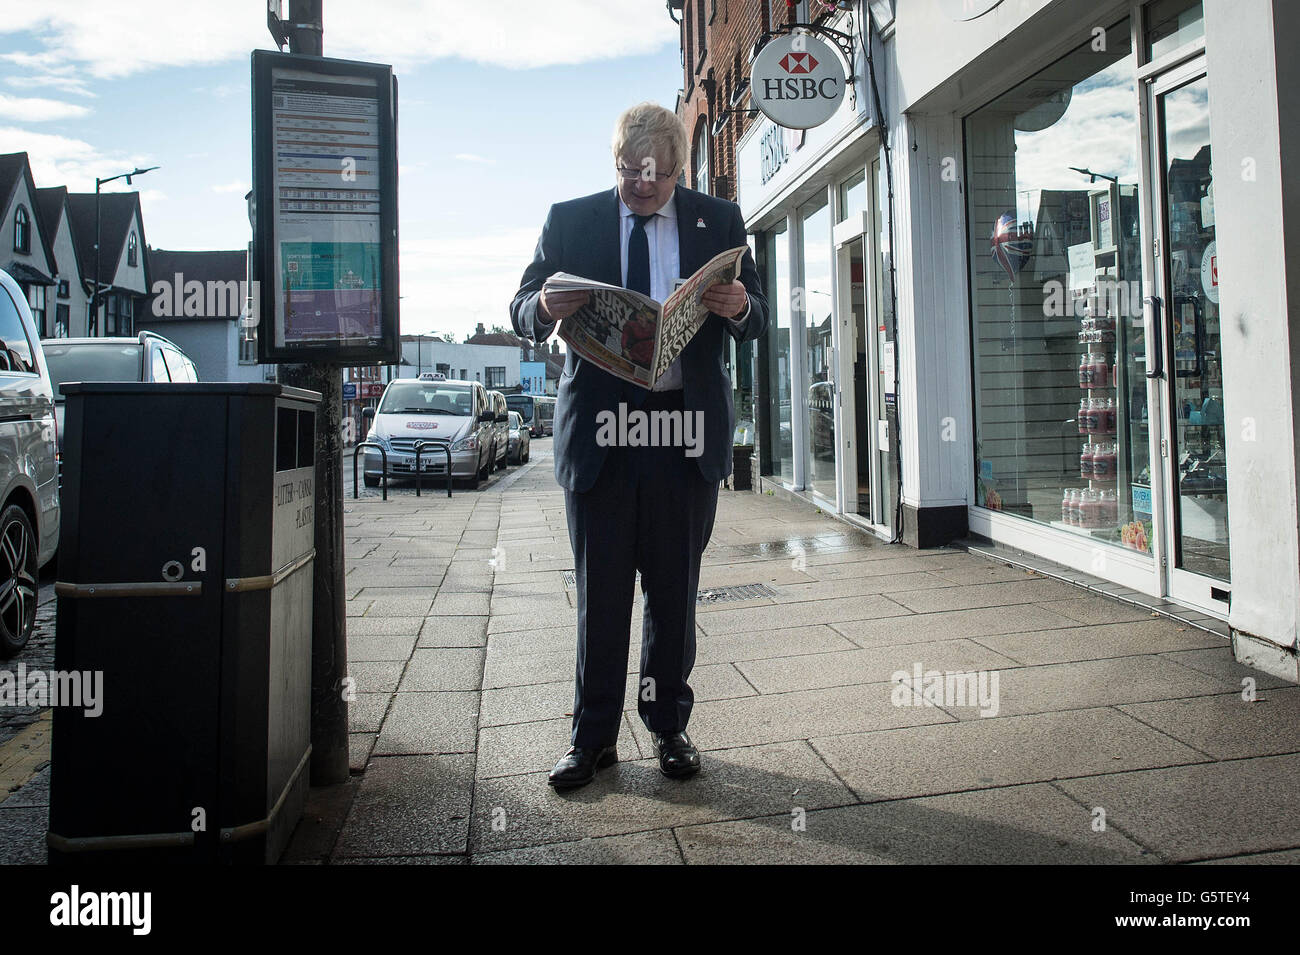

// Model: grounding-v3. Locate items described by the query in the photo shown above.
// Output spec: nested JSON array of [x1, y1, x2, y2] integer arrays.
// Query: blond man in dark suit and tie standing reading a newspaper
[[510, 103, 767, 789]]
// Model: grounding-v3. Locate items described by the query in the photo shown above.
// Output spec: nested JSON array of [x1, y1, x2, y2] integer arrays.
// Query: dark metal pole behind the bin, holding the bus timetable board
[[280, 0, 348, 786]]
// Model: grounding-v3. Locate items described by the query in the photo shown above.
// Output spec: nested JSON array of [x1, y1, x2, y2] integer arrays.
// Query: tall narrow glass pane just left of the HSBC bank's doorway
[[796, 191, 836, 500]]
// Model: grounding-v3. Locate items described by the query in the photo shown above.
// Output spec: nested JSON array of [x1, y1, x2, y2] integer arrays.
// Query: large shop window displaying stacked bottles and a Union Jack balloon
[[965, 14, 1151, 550]]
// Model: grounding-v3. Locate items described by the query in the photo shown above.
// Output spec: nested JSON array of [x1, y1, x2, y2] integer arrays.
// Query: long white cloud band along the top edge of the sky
[[0, 0, 679, 84]]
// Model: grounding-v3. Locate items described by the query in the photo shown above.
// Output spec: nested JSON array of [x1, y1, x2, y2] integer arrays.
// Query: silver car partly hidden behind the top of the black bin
[[44, 331, 199, 453]]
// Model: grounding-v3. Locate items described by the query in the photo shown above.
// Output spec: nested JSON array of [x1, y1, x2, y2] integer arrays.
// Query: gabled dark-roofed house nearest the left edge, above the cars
[[0, 152, 59, 338]]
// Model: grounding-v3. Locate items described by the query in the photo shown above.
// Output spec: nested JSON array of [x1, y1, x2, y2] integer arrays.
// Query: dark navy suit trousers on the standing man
[[564, 390, 718, 747]]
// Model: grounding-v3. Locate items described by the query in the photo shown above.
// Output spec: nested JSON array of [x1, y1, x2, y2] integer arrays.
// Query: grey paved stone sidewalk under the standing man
[[286, 442, 1300, 864]]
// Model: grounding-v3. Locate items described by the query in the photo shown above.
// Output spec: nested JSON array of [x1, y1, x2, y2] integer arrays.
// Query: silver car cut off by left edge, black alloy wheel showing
[[0, 270, 59, 657]]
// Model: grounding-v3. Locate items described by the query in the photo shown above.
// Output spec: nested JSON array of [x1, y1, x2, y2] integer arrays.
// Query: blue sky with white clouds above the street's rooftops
[[0, 0, 683, 340]]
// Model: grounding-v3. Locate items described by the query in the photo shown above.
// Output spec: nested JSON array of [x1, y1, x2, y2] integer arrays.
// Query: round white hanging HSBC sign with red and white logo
[[749, 34, 845, 130]]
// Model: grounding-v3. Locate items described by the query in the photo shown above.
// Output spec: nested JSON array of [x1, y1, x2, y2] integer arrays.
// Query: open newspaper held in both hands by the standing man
[[543, 246, 749, 388]]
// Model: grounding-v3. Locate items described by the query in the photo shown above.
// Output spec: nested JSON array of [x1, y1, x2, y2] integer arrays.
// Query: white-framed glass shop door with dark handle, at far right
[[1151, 58, 1231, 613]]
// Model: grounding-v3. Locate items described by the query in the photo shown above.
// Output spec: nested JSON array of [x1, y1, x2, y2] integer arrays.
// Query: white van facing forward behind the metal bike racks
[[361, 372, 504, 487]]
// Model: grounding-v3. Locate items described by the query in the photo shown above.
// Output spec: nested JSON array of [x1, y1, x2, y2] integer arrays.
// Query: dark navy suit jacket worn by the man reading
[[510, 186, 767, 491]]
